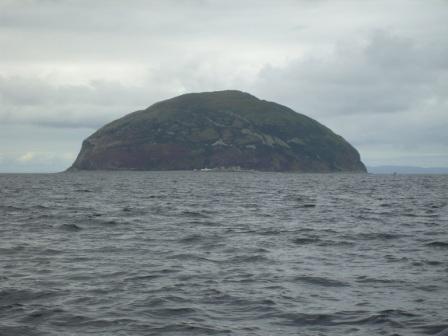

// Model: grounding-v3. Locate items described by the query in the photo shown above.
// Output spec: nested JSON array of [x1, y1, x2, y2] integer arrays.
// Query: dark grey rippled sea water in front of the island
[[0, 172, 448, 336]]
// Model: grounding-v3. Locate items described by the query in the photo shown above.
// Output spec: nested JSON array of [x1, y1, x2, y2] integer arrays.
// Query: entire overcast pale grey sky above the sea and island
[[0, 0, 448, 172]]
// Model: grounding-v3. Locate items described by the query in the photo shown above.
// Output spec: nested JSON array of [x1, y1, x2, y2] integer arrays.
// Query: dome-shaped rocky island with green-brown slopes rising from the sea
[[69, 91, 366, 172]]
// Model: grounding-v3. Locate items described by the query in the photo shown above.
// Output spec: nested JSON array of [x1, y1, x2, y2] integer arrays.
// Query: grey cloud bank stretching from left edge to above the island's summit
[[0, 60, 252, 129]]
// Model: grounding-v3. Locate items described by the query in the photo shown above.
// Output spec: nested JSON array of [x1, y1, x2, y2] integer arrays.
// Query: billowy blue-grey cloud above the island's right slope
[[254, 31, 448, 115]]
